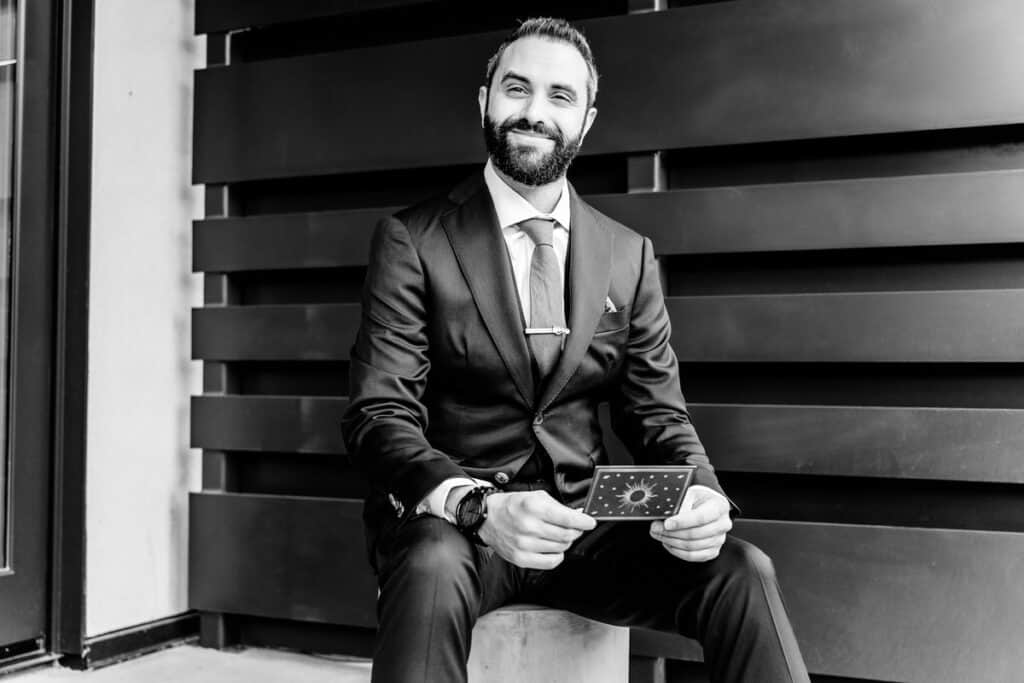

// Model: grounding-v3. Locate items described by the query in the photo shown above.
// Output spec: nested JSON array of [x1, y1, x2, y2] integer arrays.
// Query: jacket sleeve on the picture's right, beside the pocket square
[[609, 238, 725, 505]]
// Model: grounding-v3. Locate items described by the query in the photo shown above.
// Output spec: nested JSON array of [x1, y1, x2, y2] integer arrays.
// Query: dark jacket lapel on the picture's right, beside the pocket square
[[539, 185, 611, 411]]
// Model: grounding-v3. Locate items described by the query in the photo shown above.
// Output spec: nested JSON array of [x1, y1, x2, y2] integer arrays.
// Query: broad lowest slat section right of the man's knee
[[734, 520, 1024, 683]]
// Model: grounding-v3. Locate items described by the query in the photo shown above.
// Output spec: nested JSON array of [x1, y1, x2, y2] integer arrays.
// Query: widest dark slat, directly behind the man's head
[[194, 0, 1024, 182]]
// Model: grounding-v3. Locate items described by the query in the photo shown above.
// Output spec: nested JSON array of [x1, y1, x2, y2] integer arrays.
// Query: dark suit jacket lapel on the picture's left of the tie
[[441, 179, 536, 407]]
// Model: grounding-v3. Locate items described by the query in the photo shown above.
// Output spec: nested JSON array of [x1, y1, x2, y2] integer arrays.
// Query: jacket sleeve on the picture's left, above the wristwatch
[[341, 218, 466, 510]]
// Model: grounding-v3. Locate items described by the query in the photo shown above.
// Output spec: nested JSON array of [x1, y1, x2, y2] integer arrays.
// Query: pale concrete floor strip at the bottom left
[[7, 645, 370, 683]]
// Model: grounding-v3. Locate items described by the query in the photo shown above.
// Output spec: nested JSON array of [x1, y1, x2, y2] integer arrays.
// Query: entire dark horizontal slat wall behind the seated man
[[189, 0, 1024, 683]]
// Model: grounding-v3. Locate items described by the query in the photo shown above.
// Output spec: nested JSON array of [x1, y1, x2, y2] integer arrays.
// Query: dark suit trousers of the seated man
[[373, 515, 809, 683]]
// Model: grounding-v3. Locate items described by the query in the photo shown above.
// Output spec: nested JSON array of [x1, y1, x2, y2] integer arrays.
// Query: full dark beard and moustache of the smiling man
[[483, 115, 583, 187]]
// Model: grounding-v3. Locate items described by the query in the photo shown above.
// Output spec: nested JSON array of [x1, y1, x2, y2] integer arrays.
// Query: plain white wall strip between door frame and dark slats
[[86, 0, 205, 636]]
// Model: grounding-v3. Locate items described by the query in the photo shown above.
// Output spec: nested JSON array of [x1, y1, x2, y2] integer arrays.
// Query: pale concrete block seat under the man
[[469, 604, 630, 683]]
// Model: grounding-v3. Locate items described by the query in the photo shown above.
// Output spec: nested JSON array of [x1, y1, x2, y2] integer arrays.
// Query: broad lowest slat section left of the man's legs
[[188, 494, 377, 626]]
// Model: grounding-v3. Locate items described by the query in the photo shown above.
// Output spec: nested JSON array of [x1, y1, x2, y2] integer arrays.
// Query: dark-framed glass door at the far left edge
[[0, 0, 59, 668]]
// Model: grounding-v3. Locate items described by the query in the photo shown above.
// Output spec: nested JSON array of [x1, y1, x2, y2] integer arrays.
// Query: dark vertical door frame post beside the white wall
[[49, 0, 95, 661]]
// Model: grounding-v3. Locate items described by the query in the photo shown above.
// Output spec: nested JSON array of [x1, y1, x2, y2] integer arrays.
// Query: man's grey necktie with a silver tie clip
[[519, 218, 568, 378]]
